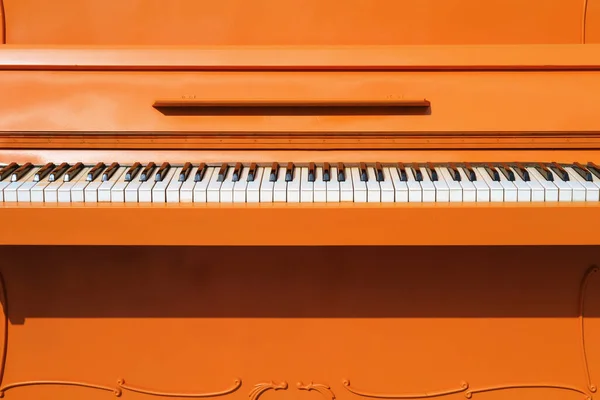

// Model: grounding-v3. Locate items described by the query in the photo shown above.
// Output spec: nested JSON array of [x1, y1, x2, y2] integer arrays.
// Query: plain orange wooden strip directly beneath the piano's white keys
[[0, 202, 600, 247]]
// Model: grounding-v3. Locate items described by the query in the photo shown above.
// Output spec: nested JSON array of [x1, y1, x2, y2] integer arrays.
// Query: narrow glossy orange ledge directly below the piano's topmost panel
[[0, 45, 600, 71]]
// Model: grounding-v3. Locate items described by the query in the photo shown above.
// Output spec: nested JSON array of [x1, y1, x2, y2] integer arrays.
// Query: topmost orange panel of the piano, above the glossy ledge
[[4, 0, 583, 45]]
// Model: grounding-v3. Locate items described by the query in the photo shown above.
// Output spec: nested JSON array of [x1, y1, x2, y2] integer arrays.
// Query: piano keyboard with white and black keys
[[0, 162, 600, 203]]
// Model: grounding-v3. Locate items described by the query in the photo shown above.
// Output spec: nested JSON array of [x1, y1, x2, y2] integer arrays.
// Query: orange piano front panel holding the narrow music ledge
[[0, 69, 600, 135]]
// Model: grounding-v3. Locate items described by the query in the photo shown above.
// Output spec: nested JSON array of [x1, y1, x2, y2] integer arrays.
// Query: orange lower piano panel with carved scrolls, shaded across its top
[[0, 246, 600, 400]]
